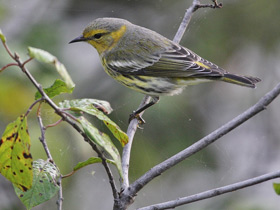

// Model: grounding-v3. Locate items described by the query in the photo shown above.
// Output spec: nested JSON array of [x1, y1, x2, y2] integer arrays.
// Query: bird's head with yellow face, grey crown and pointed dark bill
[[69, 18, 131, 54]]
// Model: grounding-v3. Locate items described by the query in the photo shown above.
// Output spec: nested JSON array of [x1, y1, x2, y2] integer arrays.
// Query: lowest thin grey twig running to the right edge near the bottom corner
[[138, 171, 280, 210]]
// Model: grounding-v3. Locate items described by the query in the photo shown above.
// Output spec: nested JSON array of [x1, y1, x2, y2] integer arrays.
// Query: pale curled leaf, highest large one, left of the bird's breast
[[28, 47, 75, 89]]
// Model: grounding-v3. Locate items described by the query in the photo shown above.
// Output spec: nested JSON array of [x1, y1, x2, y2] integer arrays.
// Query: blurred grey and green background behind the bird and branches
[[0, 0, 280, 210]]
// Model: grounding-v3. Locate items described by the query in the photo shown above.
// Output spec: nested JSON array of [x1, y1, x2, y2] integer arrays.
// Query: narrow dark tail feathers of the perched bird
[[222, 73, 261, 88]]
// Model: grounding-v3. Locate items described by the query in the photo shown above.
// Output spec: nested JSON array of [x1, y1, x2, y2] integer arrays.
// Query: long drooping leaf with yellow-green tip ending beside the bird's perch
[[59, 99, 128, 146]]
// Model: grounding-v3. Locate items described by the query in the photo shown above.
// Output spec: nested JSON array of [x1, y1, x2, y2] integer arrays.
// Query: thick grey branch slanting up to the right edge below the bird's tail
[[126, 83, 280, 200]]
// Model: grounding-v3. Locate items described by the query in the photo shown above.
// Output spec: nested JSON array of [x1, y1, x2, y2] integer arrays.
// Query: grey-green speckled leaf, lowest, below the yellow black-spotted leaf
[[15, 159, 60, 209]]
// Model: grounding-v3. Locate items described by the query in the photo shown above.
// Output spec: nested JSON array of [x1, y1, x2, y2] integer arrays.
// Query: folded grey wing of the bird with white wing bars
[[107, 44, 225, 77]]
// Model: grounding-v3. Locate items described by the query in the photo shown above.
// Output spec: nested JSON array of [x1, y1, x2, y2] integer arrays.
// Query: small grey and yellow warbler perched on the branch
[[69, 17, 261, 122]]
